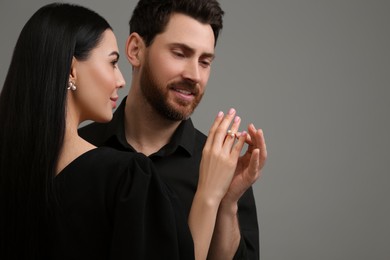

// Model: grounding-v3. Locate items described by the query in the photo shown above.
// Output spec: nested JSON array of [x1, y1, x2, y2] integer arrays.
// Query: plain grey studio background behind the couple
[[0, 0, 390, 260]]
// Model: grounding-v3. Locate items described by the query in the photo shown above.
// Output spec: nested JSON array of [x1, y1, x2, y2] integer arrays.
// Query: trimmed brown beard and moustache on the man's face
[[140, 55, 203, 121]]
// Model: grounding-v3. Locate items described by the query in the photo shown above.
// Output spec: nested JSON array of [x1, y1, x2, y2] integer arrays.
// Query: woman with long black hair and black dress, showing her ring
[[0, 4, 246, 259]]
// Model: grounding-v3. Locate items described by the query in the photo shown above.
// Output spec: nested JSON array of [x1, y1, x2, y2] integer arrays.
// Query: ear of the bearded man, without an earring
[[126, 33, 146, 68]]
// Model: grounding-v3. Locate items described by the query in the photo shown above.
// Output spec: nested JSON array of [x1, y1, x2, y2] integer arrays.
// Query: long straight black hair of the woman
[[0, 3, 111, 259]]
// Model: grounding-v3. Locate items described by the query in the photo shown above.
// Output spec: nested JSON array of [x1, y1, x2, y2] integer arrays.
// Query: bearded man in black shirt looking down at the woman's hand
[[80, 0, 266, 259]]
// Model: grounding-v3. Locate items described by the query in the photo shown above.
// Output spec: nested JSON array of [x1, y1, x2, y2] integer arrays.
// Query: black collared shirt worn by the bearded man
[[79, 98, 259, 260]]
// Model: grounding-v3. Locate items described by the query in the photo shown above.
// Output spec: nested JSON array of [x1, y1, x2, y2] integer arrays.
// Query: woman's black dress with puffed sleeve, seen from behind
[[48, 147, 194, 260]]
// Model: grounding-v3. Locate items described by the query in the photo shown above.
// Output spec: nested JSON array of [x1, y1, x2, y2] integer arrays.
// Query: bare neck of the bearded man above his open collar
[[125, 88, 181, 156]]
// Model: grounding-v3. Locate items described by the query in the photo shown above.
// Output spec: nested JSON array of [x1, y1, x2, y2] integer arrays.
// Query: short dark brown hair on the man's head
[[129, 0, 224, 47]]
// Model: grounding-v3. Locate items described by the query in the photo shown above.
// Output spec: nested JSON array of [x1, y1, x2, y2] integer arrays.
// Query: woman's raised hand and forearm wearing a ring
[[188, 109, 246, 260]]
